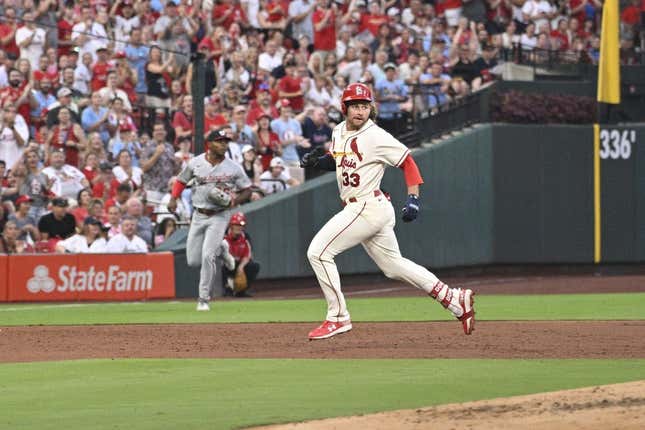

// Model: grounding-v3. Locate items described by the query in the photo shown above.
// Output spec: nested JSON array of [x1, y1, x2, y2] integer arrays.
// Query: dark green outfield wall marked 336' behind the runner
[[219, 124, 645, 278]]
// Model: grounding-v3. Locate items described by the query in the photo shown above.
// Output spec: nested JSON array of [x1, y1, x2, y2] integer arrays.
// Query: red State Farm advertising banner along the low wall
[[7, 252, 175, 302]]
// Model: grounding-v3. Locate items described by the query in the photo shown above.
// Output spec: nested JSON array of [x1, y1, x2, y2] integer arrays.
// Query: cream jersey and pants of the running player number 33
[[307, 120, 452, 322]]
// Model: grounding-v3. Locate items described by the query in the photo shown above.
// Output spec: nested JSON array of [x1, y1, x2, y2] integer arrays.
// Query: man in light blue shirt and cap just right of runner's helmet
[[374, 63, 408, 135]]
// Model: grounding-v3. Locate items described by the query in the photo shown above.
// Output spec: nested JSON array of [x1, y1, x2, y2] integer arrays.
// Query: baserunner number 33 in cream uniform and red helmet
[[301, 83, 475, 340]]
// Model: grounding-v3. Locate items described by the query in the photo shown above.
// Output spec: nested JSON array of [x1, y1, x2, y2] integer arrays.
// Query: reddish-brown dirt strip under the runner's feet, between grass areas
[[0, 321, 645, 362]]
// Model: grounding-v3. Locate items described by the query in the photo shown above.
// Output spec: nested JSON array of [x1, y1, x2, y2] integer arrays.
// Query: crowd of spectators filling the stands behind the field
[[0, 0, 645, 253]]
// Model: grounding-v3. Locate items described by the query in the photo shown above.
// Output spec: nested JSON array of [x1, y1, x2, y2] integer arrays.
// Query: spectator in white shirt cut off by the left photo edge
[[0, 102, 29, 170]]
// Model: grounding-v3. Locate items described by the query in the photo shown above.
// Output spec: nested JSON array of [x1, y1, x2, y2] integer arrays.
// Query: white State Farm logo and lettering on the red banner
[[27, 264, 154, 294]]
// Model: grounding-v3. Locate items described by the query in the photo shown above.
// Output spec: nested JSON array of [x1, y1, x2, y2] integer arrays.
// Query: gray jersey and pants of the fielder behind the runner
[[179, 154, 251, 302]]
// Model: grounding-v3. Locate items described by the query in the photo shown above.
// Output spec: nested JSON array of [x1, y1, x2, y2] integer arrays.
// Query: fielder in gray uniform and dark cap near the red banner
[[168, 130, 251, 311]]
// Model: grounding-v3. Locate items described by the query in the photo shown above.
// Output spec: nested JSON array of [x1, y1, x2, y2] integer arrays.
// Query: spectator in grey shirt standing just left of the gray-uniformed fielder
[[141, 122, 180, 206]]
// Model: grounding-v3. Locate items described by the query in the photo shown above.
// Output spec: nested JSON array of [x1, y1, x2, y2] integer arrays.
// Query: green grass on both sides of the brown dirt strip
[[0, 294, 645, 430]]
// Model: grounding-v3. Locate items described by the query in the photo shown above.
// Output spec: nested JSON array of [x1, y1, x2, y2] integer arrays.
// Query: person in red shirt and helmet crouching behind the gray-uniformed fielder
[[222, 212, 260, 297]]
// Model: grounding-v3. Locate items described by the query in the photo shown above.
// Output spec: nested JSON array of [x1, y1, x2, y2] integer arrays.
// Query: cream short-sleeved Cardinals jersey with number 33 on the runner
[[329, 120, 410, 201]]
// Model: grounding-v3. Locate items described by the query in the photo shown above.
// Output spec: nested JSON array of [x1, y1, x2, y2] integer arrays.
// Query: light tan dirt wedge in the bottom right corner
[[250, 381, 645, 430]]
